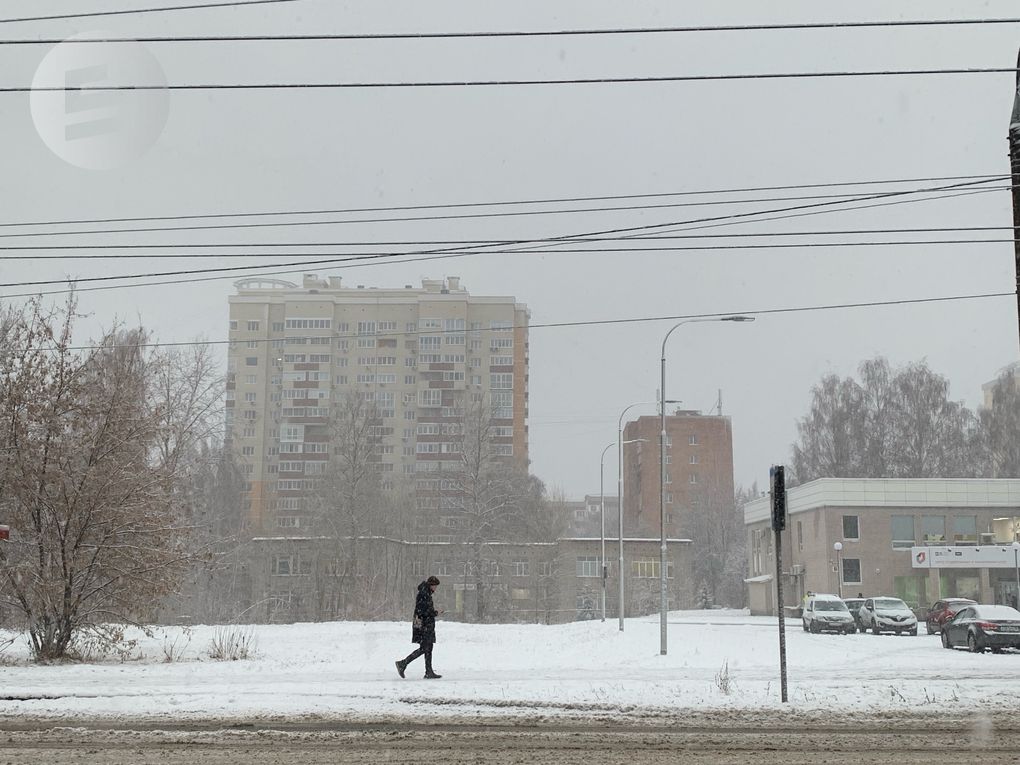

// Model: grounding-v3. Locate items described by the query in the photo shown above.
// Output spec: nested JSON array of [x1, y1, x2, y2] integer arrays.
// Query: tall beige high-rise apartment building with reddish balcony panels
[[225, 274, 529, 534]]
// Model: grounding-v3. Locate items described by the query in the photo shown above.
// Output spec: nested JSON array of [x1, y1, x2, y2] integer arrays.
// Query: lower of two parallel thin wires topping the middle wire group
[[0, 175, 1013, 239]]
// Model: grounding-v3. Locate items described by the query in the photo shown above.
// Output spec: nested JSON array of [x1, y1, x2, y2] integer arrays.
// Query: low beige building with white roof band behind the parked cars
[[744, 478, 1020, 614]]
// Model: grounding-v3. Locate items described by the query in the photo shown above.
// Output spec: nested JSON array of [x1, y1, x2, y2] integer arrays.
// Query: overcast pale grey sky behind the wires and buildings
[[0, 0, 1020, 496]]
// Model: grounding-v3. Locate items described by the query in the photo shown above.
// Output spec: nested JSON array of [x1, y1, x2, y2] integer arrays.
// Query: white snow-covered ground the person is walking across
[[0, 611, 1020, 721]]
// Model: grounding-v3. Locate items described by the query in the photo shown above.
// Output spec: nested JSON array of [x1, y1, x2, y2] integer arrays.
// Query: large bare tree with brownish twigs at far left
[[0, 298, 211, 660]]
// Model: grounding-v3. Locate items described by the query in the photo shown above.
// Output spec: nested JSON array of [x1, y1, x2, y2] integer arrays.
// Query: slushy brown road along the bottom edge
[[0, 714, 1020, 765]]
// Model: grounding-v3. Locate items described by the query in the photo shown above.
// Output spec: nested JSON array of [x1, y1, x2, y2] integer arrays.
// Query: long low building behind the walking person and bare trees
[[249, 537, 693, 624]]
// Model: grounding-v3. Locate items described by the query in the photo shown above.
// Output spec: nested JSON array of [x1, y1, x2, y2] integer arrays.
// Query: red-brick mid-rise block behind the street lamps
[[623, 410, 733, 542]]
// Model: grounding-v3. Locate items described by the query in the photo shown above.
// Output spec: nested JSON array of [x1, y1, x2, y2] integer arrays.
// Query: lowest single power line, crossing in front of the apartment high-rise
[[27, 292, 1016, 352]]
